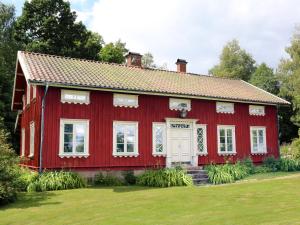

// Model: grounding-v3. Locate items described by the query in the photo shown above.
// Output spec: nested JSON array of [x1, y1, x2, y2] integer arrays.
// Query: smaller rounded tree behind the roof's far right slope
[[250, 63, 279, 94]]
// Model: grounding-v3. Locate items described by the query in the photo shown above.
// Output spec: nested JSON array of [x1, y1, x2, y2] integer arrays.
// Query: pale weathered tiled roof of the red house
[[18, 52, 289, 104]]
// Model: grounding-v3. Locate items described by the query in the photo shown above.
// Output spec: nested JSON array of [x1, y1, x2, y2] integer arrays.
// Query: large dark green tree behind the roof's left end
[[15, 0, 103, 59]]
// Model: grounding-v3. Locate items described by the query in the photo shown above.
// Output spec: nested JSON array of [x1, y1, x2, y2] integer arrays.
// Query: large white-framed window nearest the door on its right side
[[218, 125, 236, 155]]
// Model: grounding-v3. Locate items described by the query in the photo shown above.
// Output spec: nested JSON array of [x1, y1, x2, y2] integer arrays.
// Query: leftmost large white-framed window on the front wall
[[59, 119, 89, 157]]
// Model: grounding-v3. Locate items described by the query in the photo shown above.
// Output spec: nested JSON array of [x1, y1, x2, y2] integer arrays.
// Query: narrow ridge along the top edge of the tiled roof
[[20, 51, 241, 80]]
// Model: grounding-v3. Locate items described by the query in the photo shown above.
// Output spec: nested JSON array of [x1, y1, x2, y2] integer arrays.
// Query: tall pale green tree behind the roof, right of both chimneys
[[209, 40, 255, 81]]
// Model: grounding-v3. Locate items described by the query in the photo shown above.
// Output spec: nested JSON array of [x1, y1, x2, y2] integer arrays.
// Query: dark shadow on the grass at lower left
[[0, 192, 61, 211]]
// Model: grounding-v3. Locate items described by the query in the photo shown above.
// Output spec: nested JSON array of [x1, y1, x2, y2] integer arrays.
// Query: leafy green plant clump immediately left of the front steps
[[137, 168, 193, 187]]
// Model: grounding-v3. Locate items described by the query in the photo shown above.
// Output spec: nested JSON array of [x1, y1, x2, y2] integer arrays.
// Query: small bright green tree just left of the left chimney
[[99, 40, 128, 64]]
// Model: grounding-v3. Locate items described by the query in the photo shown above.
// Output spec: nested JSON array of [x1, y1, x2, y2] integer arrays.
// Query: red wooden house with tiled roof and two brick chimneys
[[12, 52, 289, 174]]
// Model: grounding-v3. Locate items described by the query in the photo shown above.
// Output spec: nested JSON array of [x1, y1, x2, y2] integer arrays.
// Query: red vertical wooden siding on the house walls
[[22, 88, 279, 169]]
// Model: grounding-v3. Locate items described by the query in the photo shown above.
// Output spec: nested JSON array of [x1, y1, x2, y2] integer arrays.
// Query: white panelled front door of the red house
[[170, 129, 191, 162]]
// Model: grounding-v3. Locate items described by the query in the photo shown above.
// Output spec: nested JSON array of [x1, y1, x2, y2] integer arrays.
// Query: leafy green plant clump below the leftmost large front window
[[27, 171, 86, 192]]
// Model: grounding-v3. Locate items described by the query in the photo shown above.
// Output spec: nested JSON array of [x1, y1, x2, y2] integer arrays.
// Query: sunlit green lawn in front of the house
[[0, 173, 300, 225]]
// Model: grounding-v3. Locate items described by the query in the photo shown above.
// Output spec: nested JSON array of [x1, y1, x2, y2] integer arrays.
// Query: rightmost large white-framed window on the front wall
[[250, 127, 267, 154]]
